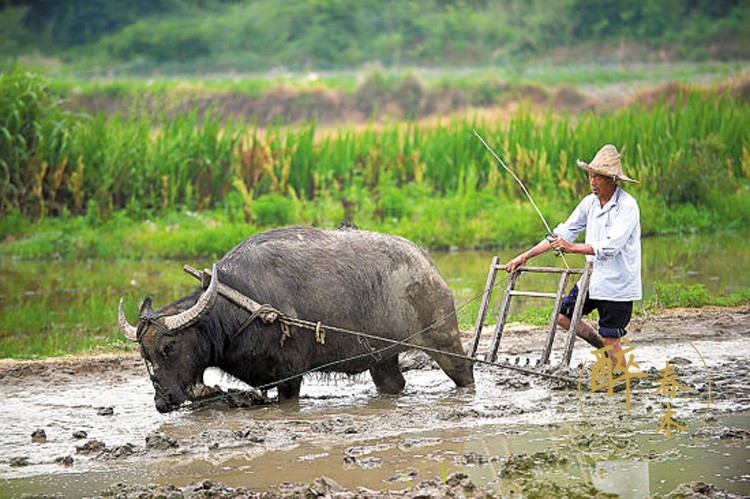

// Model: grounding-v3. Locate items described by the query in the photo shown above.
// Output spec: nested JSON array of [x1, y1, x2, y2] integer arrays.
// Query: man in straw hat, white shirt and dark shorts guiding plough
[[505, 144, 641, 367]]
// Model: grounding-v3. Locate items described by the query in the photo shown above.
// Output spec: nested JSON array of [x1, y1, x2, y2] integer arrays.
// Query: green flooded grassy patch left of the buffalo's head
[[0, 260, 182, 358]]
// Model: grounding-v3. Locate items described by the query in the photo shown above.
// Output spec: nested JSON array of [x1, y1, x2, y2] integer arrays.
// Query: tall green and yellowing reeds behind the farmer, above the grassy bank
[[0, 71, 750, 229]]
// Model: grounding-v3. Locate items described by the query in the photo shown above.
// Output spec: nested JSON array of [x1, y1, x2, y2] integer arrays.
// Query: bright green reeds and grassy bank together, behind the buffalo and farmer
[[0, 70, 750, 257]]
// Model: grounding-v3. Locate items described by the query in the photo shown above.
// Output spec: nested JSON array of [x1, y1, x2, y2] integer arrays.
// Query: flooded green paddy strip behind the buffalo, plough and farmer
[[0, 230, 750, 358]]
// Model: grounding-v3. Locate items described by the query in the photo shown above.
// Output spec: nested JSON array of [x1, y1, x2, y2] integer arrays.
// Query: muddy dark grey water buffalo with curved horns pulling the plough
[[118, 227, 474, 412]]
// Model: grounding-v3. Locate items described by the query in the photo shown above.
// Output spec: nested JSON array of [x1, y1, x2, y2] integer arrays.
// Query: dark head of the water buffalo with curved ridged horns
[[118, 266, 218, 412]]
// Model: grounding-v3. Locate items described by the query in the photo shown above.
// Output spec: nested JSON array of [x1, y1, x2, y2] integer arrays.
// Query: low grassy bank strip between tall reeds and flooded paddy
[[0, 191, 750, 260]]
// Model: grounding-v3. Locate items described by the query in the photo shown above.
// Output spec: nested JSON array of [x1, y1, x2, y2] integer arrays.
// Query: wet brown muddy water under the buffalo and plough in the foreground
[[0, 308, 750, 497]]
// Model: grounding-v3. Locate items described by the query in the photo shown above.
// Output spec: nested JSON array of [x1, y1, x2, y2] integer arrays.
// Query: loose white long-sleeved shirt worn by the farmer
[[555, 187, 643, 301]]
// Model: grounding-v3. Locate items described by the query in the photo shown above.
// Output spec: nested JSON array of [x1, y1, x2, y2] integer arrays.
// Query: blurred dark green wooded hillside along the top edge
[[0, 0, 750, 72]]
